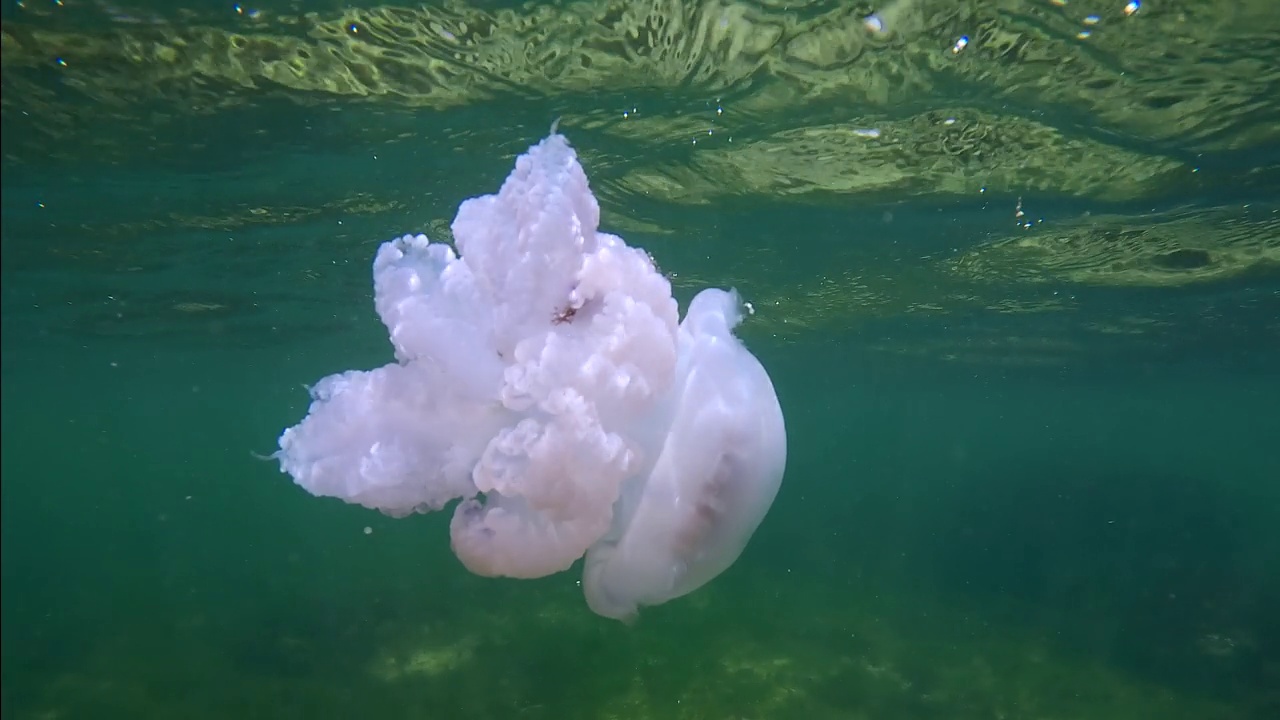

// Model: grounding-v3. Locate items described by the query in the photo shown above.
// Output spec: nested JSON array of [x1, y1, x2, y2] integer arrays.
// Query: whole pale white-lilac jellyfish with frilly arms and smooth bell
[[275, 129, 786, 620]]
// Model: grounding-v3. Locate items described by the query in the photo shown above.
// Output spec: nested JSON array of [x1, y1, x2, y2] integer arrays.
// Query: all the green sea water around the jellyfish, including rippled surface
[[0, 0, 1280, 720]]
